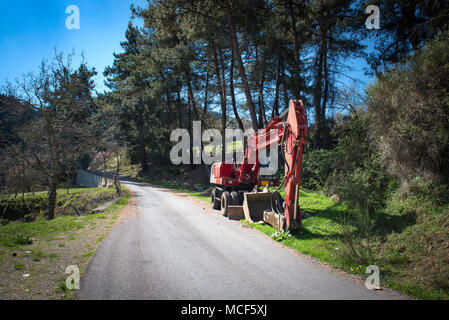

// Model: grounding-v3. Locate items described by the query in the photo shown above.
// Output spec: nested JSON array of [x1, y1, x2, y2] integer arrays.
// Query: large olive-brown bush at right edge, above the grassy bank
[[368, 33, 449, 183]]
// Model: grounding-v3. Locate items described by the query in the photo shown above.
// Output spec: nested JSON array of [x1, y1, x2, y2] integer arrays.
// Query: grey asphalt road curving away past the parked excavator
[[78, 181, 398, 300]]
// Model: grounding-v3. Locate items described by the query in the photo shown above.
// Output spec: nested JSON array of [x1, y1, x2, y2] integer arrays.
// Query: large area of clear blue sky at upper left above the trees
[[0, 0, 147, 92]]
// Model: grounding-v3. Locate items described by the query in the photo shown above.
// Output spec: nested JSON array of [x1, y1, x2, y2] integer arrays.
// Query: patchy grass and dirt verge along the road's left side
[[0, 189, 129, 300]]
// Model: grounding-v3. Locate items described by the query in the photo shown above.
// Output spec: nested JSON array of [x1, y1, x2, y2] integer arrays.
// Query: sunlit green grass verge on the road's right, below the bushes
[[251, 192, 449, 299]]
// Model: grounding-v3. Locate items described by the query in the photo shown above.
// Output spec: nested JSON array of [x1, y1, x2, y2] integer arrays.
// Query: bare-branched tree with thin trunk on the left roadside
[[4, 51, 96, 219]]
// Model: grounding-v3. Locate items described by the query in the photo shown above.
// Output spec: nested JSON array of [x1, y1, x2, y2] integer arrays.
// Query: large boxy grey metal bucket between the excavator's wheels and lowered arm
[[243, 192, 272, 223]]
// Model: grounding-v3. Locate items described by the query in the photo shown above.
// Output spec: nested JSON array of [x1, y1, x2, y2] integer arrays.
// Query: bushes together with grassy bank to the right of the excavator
[[255, 33, 449, 299]]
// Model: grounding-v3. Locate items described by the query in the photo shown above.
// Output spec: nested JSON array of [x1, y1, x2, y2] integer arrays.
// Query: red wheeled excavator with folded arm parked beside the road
[[210, 100, 307, 231]]
